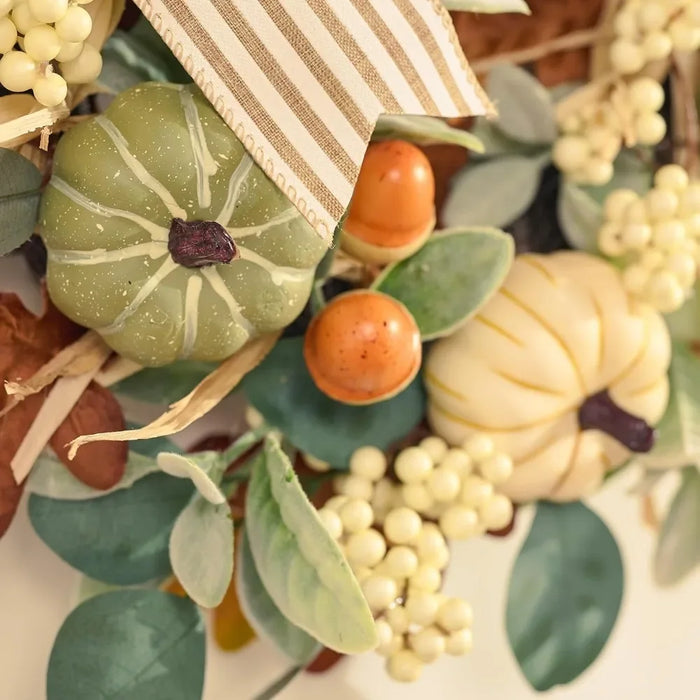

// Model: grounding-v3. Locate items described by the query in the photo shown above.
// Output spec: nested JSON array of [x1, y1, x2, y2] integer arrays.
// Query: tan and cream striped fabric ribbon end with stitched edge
[[131, 0, 493, 240]]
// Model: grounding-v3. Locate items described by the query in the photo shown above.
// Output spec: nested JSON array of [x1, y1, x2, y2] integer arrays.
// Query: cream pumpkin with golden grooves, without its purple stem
[[425, 251, 671, 502]]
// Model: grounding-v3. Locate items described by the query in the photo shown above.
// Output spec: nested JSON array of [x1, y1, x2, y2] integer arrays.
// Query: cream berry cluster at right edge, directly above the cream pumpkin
[[598, 165, 700, 313]]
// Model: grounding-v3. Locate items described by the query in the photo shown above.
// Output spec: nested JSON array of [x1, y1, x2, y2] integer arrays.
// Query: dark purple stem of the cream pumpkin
[[578, 390, 656, 452]]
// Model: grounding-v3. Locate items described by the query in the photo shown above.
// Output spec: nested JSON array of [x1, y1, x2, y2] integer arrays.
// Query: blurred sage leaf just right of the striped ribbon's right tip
[[489, 64, 559, 144]]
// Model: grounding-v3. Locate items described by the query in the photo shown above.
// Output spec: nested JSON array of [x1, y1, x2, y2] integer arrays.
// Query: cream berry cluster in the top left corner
[[0, 0, 102, 107]]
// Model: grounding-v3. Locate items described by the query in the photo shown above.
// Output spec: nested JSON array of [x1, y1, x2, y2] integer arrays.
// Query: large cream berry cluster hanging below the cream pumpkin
[[319, 435, 513, 682]]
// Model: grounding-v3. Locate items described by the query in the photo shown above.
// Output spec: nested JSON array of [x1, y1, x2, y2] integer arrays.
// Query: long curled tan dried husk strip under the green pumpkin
[[68, 333, 279, 459]]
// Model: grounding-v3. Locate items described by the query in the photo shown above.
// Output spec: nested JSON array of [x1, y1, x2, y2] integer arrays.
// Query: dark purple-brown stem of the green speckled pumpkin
[[168, 219, 240, 268]]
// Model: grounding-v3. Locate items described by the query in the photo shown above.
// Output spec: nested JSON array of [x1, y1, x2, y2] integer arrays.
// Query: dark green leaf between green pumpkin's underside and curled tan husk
[[110, 360, 217, 404]]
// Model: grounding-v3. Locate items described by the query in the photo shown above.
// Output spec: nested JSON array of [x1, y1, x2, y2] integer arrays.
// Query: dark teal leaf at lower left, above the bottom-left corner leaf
[[29, 474, 194, 585]]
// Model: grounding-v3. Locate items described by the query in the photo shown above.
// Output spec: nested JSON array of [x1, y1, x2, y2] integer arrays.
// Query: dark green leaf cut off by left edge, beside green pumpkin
[[0, 148, 41, 255]]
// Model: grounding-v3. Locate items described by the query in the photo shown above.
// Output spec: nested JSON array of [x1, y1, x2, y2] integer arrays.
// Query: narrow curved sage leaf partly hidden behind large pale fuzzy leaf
[[236, 530, 319, 664]]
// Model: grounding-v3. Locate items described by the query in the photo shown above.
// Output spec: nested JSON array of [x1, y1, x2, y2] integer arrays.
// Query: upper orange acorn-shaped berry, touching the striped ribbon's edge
[[341, 141, 435, 264]]
